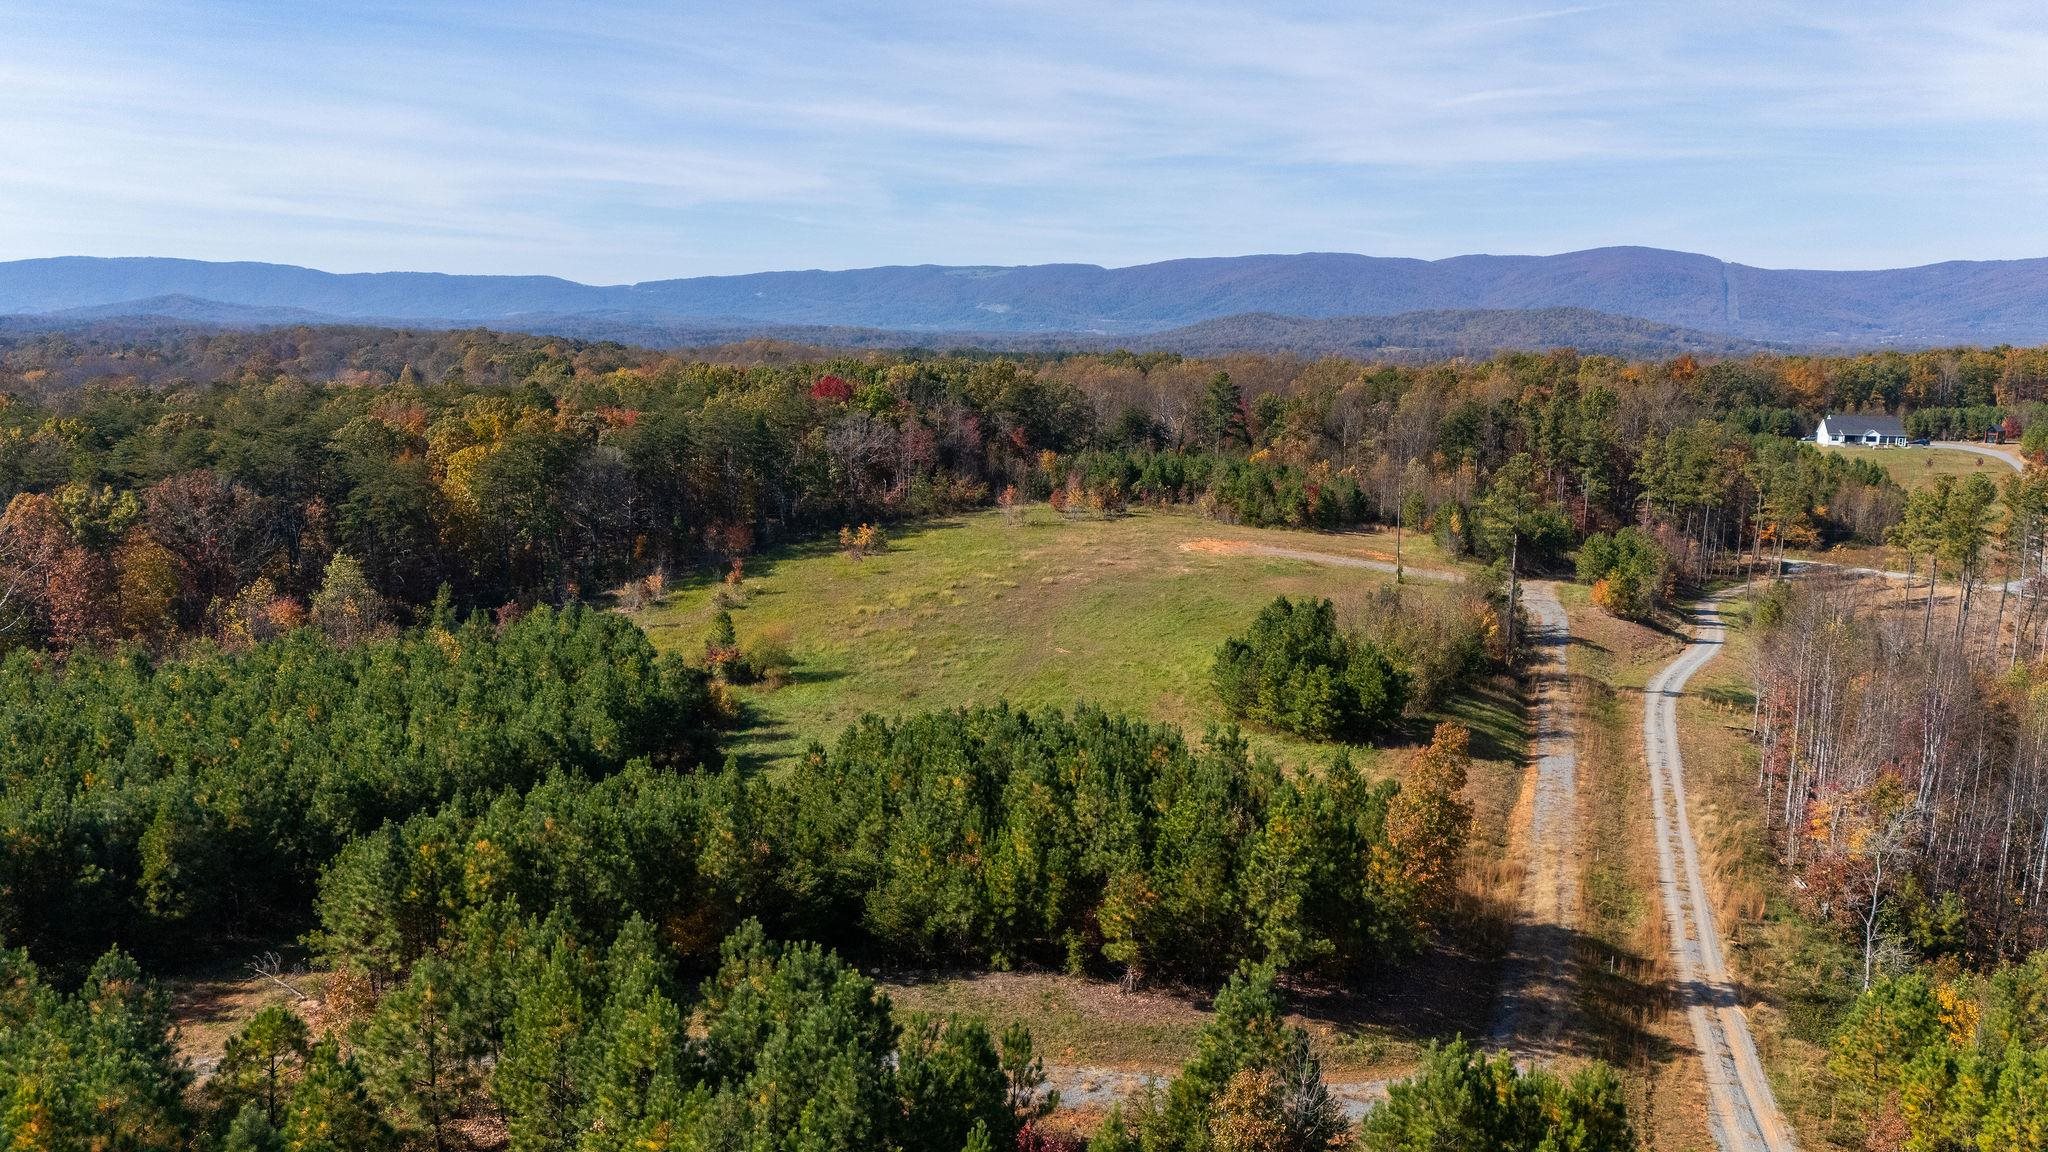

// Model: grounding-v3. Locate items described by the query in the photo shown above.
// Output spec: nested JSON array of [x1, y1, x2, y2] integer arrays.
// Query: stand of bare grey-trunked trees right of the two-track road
[[1751, 561, 2048, 967]]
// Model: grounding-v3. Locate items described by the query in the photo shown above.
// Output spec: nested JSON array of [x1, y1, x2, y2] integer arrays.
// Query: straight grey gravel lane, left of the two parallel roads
[[1487, 582, 1579, 1058]]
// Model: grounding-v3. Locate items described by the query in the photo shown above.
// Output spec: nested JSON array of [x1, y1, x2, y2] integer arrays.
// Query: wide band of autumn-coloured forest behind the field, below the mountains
[[0, 328, 2048, 660]]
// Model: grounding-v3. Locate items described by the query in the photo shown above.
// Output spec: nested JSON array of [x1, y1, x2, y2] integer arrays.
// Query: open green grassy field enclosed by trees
[[635, 508, 1520, 763]]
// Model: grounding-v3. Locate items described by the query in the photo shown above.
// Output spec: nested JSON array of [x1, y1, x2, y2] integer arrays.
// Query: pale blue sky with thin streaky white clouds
[[0, 0, 2048, 283]]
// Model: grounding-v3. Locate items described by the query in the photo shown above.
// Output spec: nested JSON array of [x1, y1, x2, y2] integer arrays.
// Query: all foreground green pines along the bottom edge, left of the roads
[[0, 934, 1636, 1152]]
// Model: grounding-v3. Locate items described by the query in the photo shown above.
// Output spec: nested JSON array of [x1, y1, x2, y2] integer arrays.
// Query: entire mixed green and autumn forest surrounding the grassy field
[[12, 328, 2048, 1152]]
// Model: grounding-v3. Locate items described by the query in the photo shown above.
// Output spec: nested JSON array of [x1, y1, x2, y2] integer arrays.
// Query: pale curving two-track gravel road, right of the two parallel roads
[[1642, 601, 1798, 1152]]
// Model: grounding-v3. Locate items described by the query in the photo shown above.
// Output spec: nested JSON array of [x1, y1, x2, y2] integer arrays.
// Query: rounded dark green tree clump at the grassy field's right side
[[1212, 596, 1409, 740]]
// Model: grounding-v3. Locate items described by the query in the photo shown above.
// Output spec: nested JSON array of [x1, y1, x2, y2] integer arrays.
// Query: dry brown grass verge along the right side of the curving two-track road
[[1677, 601, 1858, 1150]]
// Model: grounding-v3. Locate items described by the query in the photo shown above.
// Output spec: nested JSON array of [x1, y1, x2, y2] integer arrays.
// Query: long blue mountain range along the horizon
[[12, 248, 2048, 353]]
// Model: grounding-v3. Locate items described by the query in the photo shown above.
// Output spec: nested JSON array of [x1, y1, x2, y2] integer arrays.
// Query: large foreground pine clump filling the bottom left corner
[[0, 920, 1051, 1152]]
